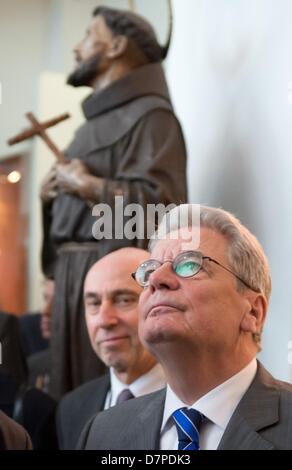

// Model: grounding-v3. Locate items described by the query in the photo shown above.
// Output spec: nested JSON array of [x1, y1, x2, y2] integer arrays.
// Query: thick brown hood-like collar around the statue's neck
[[82, 63, 170, 119]]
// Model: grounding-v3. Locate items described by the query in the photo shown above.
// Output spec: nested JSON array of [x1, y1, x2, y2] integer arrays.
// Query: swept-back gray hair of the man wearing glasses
[[149, 204, 271, 301]]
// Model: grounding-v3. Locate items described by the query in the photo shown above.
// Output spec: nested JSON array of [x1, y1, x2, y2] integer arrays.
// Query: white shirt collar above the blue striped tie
[[162, 358, 257, 430]]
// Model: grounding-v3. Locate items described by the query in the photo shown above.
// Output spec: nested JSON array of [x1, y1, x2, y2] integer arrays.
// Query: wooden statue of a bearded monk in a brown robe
[[15, 7, 187, 398]]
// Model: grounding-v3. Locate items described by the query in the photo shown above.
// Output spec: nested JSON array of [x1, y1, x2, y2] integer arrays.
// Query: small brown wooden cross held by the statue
[[7, 113, 70, 163]]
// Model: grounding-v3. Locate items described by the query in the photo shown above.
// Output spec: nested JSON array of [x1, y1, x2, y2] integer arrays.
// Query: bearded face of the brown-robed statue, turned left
[[67, 16, 113, 87]]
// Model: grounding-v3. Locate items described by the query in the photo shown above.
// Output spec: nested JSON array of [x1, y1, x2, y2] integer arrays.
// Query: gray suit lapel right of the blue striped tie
[[218, 363, 280, 450]]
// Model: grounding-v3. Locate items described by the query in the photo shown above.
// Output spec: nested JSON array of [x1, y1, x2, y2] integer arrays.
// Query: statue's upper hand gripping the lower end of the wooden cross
[[56, 159, 90, 196]]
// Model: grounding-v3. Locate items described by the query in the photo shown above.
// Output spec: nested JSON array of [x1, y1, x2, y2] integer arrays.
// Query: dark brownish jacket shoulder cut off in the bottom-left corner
[[0, 411, 32, 450]]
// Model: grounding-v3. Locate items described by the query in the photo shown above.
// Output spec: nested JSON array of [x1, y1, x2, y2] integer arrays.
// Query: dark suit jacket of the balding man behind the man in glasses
[[57, 374, 110, 450]]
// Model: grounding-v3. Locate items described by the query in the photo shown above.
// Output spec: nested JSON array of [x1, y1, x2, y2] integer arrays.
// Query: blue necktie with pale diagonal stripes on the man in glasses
[[172, 408, 204, 450]]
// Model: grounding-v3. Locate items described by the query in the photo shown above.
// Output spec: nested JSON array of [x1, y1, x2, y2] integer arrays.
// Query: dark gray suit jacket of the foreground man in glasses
[[77, 364, 292, 450]]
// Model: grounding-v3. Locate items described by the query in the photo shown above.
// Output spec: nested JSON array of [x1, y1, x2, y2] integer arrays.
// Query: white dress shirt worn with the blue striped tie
[[160, 359, 257, 450]]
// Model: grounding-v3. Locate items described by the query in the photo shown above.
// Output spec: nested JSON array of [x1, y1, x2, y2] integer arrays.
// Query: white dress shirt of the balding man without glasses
[[104, 364, 165, 410]]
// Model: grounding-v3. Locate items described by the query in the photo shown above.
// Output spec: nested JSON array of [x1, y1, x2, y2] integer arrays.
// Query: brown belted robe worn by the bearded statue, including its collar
[[43, 64, 187, 397]]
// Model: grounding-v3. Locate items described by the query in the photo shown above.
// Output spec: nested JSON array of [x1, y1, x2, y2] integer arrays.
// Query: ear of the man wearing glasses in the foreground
[[240, 292, 268, 334]]
